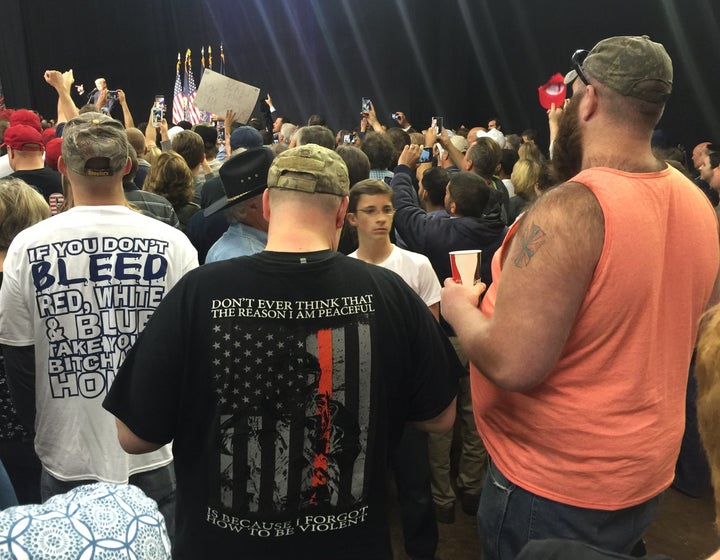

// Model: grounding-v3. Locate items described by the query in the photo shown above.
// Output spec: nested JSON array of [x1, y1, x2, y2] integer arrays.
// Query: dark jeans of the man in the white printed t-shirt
[[40, 463, 176, 542]]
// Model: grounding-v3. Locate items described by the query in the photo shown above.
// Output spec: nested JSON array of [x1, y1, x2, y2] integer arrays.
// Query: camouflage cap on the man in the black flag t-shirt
[[268, 144, 350, 196]]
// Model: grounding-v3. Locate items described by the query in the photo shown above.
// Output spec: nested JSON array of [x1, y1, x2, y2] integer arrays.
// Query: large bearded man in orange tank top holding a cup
[[441, 37, 719, 560]]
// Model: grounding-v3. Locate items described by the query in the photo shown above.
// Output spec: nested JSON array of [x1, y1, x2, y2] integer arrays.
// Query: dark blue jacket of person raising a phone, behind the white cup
[[390, 165, 507, 285]]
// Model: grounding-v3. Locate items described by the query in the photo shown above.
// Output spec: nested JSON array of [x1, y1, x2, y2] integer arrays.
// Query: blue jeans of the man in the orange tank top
[[477, 461, 660, 560]]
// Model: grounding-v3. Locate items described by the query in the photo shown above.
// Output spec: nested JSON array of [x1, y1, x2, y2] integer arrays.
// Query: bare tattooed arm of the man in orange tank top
[[441, 183, 605, 391]]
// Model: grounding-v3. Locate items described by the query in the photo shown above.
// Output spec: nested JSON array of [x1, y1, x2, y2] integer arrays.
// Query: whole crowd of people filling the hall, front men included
[[0, 37, 720, 560]]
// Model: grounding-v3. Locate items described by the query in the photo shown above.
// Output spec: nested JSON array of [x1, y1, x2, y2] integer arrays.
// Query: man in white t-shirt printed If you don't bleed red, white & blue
[[0, 113, 197, 533]]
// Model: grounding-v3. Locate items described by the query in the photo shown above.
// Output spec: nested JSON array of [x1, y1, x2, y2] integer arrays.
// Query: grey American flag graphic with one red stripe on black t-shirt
[[211, 318, 372, 514]]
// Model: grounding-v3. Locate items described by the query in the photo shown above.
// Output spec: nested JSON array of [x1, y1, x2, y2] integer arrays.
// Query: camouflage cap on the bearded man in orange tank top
[[565, 35, 673, 103]]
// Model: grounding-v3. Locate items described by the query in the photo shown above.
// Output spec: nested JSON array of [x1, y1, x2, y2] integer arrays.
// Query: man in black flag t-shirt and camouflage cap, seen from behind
[[104, 144, 461, 560]]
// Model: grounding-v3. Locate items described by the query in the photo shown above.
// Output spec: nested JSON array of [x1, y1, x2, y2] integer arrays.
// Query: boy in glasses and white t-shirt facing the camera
[[347, 179, 440, 558]]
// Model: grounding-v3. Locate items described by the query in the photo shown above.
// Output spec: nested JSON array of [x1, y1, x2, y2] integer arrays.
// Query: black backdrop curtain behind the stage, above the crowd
[[0, 0, 720, 151]]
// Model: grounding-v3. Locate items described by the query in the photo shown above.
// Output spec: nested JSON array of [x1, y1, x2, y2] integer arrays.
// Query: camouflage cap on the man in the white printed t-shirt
[[62, 113, 129, 177]]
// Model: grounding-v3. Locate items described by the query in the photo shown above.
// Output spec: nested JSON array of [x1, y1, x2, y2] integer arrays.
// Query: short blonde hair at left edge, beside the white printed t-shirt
[[0, 177, 50, 251]]
